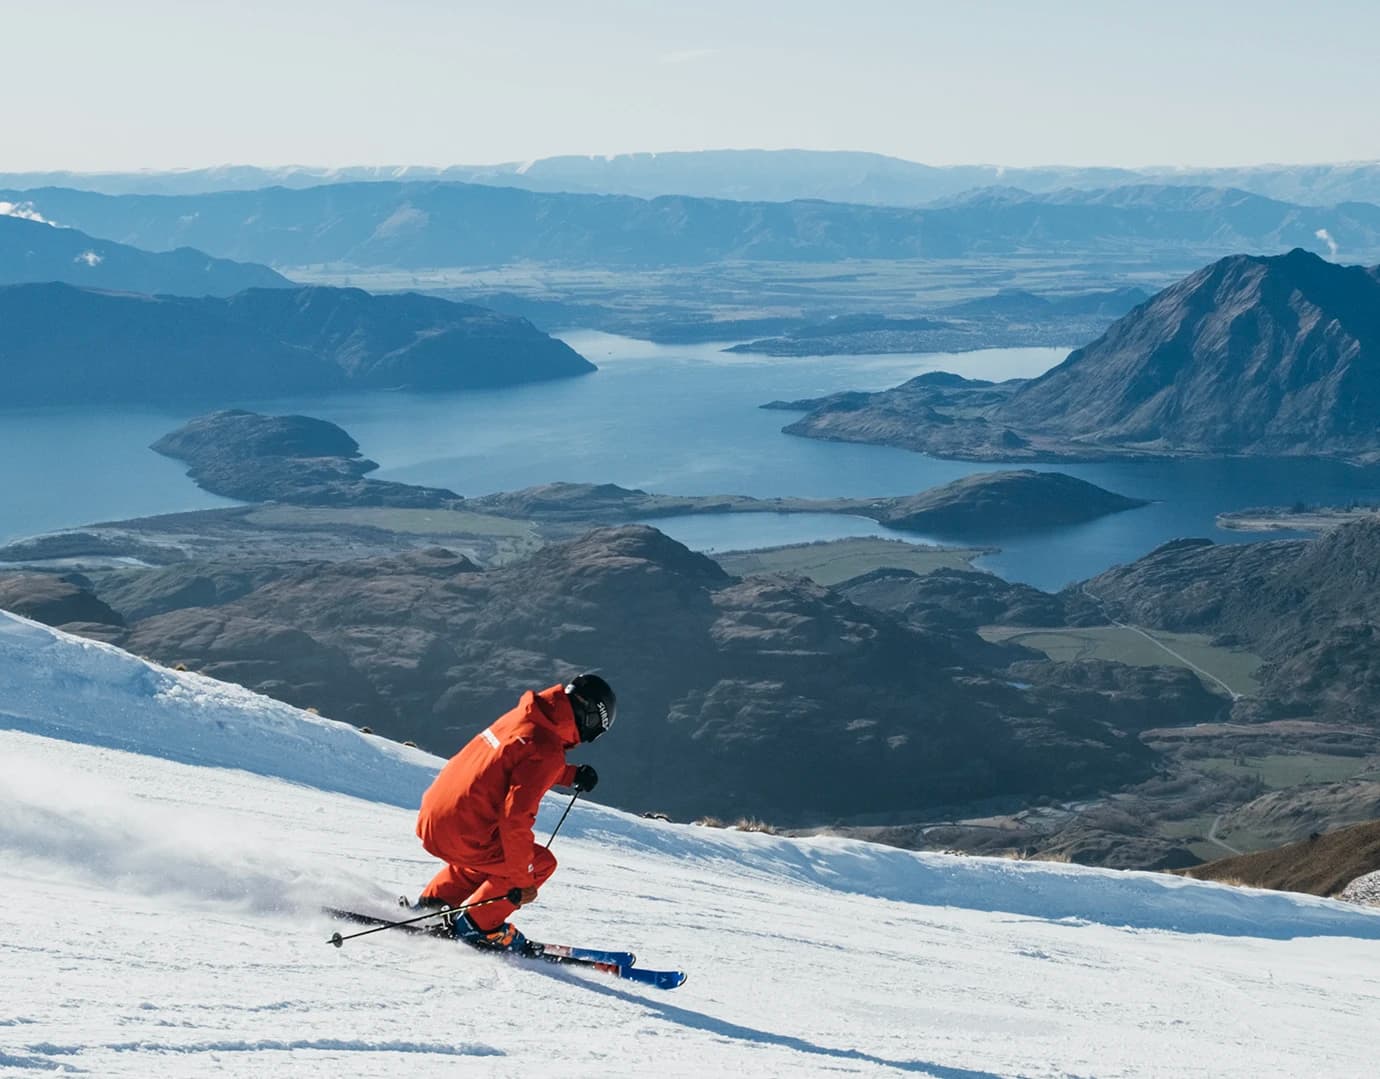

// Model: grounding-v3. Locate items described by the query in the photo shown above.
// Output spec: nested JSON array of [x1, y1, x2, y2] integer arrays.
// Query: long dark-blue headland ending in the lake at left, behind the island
[[0, 284, 595, 406]]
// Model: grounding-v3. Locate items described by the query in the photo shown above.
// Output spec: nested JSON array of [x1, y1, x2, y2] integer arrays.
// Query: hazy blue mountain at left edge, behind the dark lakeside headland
[[0, 214, 293, 297]]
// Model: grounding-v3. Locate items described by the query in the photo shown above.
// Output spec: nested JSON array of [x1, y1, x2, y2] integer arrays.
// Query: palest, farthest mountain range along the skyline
[[8, 150, 1380, 206]]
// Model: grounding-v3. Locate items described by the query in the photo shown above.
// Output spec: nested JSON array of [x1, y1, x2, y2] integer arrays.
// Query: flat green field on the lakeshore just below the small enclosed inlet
[[713, 535, 983, 585]]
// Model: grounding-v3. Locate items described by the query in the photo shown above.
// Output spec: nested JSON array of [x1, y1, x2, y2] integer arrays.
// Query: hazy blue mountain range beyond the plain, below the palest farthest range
[[0, 182, 1380, 270]]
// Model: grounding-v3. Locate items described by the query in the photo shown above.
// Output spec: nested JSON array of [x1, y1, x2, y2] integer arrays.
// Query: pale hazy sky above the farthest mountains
[[0, 0, 1380, 171]]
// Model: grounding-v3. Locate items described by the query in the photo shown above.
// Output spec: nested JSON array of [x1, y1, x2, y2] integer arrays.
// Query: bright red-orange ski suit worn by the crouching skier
[[417, 684, 580, 930]]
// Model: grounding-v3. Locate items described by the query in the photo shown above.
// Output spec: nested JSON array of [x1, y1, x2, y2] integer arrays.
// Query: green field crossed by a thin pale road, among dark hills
[[978, 625, 1261, 697]]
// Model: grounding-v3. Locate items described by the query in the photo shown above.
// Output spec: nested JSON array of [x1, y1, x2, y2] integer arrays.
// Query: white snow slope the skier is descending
[[0, 613, 1380, 1079]]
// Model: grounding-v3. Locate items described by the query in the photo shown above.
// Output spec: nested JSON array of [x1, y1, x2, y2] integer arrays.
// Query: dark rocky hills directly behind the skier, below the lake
[[10, 526, 1154, 822]]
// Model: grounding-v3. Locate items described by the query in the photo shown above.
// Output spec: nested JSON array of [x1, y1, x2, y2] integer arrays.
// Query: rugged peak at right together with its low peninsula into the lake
[[773, 250, 1380, 459]]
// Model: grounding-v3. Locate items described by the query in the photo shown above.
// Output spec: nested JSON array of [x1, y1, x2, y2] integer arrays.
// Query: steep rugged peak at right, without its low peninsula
[[1010, 250, 1380, 457]]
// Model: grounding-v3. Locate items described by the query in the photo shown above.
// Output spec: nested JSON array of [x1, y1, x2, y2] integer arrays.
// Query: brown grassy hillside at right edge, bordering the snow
[[1179, 821, 1380, 895]]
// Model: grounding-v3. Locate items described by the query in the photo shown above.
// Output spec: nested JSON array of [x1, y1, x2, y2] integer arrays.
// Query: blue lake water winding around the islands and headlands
[[0, 333, 1380, 588]]
